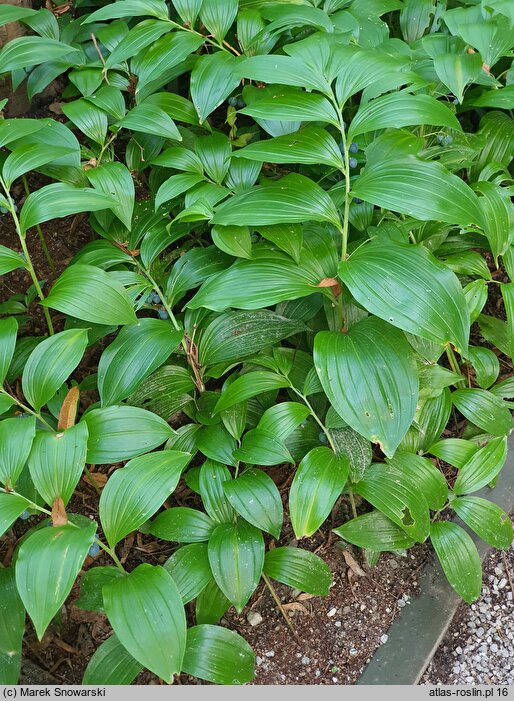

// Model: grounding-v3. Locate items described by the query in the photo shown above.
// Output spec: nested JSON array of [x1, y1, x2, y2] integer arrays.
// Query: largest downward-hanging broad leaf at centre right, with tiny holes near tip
[[314, 318, 418, 457]]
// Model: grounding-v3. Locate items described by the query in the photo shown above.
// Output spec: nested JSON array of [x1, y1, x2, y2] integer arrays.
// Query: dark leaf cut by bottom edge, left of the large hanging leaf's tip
[[82, 634, 143, 685]]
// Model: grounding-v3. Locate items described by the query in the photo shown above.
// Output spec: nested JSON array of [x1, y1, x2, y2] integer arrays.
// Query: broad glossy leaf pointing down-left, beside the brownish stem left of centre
[[98, 318, 183, 406]]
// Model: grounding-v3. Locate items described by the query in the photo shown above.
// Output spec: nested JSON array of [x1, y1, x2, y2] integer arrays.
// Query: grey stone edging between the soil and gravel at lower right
[[357, 436, 514, 685]]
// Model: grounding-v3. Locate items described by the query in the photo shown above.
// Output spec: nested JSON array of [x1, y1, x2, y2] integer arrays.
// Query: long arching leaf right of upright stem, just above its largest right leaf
[[352, 156, 485, 226]]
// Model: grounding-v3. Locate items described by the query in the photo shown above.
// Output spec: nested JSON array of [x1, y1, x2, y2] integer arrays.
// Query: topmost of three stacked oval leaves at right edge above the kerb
[[452, 389, 514, 436]]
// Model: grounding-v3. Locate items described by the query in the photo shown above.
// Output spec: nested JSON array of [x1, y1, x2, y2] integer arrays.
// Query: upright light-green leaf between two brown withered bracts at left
[[28, 423, 88, 506]]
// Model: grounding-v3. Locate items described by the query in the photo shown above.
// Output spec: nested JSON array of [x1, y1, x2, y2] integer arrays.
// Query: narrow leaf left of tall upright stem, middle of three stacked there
[[234, 127, 344, 170]]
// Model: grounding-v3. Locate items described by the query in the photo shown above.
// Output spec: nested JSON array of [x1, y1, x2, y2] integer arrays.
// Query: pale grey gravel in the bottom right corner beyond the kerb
[[421, 547, 514, 685]]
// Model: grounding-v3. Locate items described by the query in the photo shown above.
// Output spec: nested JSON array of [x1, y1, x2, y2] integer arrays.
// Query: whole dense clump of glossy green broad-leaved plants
[[0, 0, 514, 684]]
